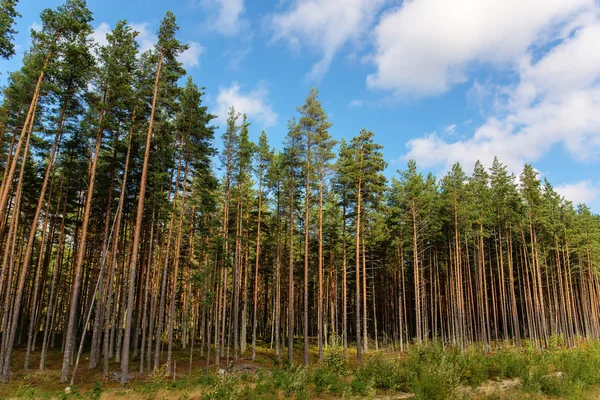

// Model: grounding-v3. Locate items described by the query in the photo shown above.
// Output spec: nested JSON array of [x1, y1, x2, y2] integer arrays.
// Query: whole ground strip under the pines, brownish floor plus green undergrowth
[[0, 340, 600, 400]]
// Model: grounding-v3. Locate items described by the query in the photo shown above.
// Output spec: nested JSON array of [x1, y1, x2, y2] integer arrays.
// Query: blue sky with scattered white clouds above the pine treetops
[[0, 0, 600, 212]]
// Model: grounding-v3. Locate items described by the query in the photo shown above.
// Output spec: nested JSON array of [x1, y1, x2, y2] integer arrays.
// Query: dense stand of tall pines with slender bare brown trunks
[[0, 0, 600, 390]]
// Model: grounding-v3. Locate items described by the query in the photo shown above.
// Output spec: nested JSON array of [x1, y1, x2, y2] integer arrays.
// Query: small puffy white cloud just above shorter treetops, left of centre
[[215, 82, 278, 128]]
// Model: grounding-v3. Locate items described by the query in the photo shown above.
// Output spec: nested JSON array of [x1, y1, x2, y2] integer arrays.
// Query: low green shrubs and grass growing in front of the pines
[[7, 339, 600, 400]]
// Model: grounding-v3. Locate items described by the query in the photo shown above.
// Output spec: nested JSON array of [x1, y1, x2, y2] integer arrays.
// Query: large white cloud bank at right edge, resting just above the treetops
[[403, 1, 600, 177]]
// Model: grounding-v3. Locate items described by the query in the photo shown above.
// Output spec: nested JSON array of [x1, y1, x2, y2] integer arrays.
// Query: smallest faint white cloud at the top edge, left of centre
[[196, 0, 248, 36]]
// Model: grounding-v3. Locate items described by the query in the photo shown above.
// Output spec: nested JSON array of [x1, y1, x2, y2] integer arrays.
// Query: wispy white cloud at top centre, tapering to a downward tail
[[269, 0, 384, 79]]
